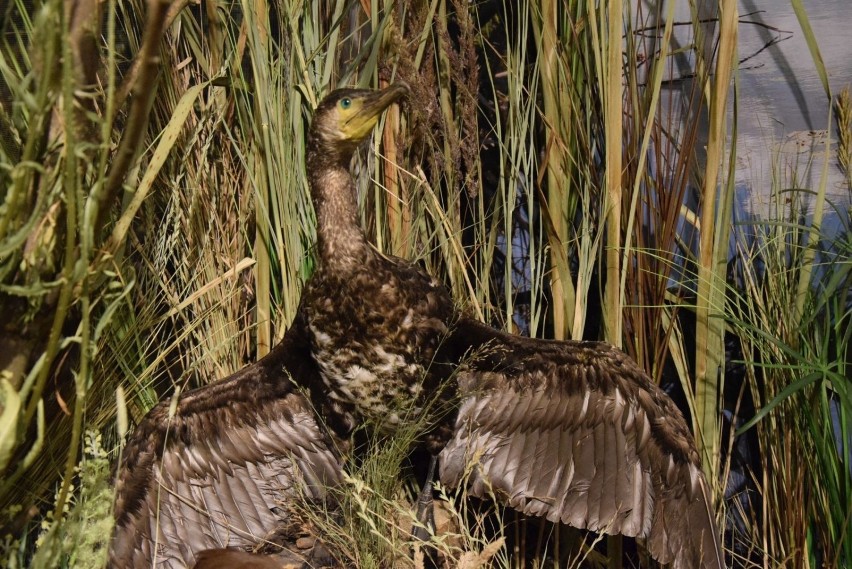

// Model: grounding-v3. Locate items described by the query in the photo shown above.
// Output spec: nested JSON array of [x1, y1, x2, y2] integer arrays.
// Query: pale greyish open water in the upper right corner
[[736, 0, 852, 237]]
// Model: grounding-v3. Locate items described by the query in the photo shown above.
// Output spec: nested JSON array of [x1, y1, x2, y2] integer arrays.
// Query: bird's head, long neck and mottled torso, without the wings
[[304, 90, 453, 430]]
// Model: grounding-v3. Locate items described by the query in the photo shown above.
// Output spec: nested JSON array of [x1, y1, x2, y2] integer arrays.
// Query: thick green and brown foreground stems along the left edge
[[0, 2, 153, 562]]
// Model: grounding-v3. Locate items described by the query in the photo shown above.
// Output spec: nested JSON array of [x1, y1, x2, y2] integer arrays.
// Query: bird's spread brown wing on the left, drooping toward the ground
[[110, 320, 340, 569]]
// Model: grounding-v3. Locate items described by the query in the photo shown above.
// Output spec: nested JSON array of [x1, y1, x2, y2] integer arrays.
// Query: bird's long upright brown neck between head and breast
[[307, 146, 370, 271]]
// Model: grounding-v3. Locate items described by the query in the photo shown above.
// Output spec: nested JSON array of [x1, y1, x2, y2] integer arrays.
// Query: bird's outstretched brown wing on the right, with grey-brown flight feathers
[[440, 320, 724, 569]]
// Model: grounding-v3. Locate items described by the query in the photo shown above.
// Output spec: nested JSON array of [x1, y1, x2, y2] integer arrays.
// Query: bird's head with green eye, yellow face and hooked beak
[[309, 83, 408, 163]]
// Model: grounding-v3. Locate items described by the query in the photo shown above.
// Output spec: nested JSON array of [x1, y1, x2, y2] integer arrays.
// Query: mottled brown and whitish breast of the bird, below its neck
[[305, 255, 451, 430]]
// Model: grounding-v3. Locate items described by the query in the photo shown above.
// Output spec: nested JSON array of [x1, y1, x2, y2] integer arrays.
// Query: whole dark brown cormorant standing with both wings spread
[[112, 86, 723, 569]]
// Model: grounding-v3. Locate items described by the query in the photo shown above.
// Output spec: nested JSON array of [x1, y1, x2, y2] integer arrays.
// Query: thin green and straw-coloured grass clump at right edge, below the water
[[729, 172, 852, 567]]
